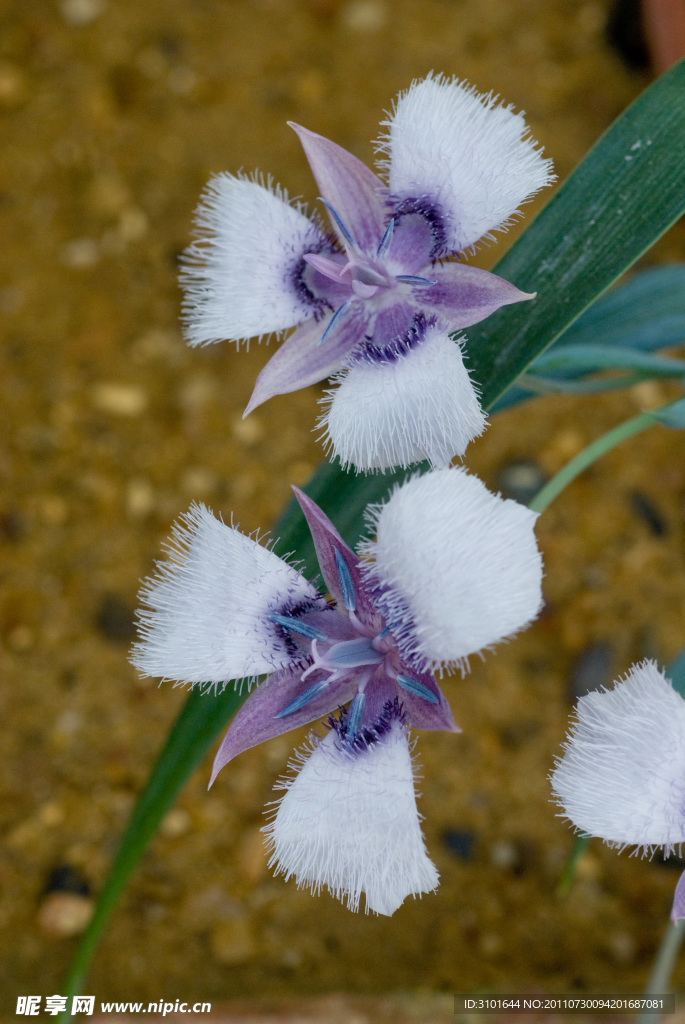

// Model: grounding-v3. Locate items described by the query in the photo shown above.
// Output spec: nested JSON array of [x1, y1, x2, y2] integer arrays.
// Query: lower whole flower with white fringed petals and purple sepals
[[133, 469, 542, 914]]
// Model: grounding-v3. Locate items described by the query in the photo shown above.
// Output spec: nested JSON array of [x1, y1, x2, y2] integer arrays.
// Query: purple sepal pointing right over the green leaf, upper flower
[[414, 263, 536, 330]]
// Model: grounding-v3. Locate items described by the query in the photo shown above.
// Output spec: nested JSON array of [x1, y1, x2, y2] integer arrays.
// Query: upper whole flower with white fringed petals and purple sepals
[[181, 76, 553, 470]]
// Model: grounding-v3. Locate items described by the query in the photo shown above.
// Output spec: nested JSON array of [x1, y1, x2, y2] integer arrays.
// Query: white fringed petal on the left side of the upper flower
[[180, 173, 324, 345]]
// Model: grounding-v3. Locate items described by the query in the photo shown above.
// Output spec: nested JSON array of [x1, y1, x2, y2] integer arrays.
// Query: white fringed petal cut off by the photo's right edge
[[551, 662, 685, 855]]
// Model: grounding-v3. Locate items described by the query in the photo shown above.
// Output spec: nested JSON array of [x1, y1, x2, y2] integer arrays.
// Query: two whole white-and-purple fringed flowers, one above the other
[[133, 76, 553, 914]]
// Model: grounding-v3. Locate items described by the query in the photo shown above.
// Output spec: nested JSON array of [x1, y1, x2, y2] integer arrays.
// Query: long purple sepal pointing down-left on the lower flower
[[209, 669, 359, 786]]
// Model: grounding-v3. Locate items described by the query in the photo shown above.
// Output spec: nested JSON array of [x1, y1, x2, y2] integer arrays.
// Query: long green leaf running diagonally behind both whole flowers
[[61, 61, 685, 993]]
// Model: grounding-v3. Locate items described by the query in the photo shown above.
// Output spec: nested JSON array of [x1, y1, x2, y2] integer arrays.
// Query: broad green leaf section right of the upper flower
[[467, 60, 685, 409]]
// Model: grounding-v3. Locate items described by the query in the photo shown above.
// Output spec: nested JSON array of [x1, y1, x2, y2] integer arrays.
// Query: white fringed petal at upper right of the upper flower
[[379, 76, 554, 252]]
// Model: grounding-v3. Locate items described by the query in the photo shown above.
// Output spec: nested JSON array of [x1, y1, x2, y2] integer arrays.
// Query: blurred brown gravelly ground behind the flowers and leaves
[[0, 0, 685, 1013]]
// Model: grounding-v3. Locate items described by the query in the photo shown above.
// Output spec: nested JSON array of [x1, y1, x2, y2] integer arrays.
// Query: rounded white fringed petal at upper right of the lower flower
[[359, 468, 543, 671]]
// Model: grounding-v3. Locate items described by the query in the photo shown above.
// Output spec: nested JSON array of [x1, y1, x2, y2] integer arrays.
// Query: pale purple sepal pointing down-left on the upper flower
[[243, 303, 368, 418]]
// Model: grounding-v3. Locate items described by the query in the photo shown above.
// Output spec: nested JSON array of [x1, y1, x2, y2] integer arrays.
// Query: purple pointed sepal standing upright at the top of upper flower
[[289, 121, 388, 256]]
